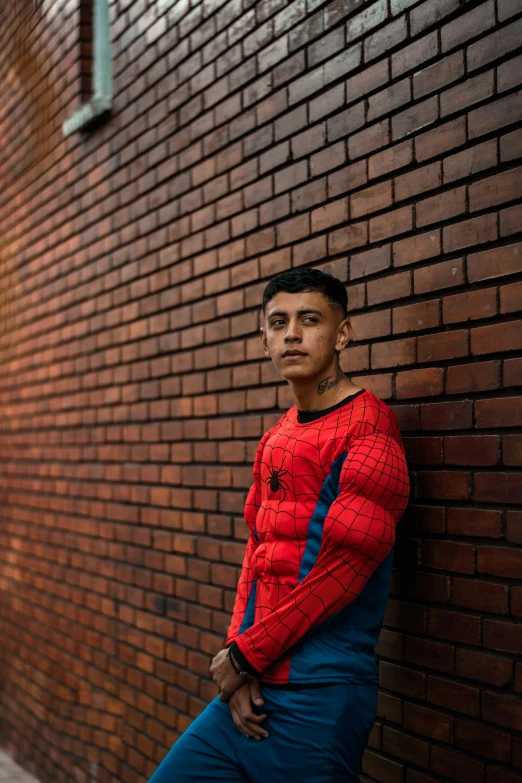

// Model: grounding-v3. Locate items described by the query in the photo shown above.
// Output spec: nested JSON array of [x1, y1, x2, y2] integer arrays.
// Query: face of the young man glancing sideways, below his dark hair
[[261, 291, 351, 380]]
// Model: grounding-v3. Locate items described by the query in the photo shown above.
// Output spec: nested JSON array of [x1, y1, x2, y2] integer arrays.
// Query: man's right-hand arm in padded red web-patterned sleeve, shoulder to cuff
[[231, 432, 409, 674]]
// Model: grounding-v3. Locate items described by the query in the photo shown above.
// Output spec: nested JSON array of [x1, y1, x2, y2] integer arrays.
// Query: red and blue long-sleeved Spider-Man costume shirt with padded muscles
[[226, 390, 410, 688]]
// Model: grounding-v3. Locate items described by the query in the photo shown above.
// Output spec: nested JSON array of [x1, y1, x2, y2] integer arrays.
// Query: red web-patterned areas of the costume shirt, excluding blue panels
[[227, 391, 409, 683]]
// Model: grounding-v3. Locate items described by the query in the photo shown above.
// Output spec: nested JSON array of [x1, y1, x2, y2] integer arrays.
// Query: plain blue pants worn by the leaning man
[[149, 683, 378, 783]]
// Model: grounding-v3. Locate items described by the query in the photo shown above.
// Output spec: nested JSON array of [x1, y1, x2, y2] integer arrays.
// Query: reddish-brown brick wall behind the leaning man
[[0, 0, 522, 783]]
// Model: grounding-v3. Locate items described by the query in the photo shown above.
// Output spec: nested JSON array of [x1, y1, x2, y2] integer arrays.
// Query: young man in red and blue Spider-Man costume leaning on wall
[[150, 269, 409, 783]]
